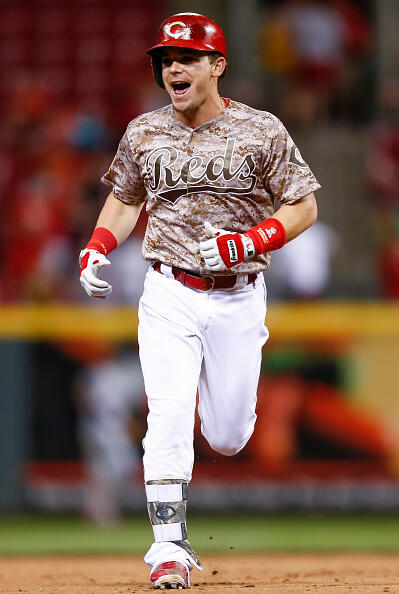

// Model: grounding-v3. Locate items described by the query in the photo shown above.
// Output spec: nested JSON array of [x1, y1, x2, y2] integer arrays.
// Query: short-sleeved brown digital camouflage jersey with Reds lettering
[[102, 101, 320, 274]]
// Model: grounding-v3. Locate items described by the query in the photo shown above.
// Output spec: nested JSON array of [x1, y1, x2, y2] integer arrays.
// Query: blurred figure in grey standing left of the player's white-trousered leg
[[76, 344, 145, 524]]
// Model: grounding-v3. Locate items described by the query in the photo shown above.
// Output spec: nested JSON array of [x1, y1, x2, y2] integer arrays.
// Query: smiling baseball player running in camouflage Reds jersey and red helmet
[[80, 13, 320, 588]]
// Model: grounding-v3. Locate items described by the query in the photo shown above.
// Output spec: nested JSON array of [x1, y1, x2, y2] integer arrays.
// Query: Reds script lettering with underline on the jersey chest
[[146, 138, 256, 204]]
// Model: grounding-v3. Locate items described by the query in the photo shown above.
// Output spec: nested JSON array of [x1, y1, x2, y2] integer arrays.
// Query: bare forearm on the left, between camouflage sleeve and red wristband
[[96, 192, 143, 245]]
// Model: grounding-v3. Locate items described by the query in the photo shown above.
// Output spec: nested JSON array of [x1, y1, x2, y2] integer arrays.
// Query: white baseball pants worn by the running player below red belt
[[138, 264, 268, 566]]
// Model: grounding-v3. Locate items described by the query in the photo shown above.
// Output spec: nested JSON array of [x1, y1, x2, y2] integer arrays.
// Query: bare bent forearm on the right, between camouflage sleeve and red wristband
[[273, 193, 317, 242]]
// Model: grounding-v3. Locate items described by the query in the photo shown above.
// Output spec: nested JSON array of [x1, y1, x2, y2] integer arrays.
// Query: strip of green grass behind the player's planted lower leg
[[0, 515, 399, 555]]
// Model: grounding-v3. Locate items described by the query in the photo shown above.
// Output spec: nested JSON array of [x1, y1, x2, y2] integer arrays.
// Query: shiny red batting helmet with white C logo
[[147, 12, 227, 89]]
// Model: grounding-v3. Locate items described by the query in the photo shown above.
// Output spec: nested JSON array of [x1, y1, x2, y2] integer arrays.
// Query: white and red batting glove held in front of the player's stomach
[[200, 221, 255, 271]]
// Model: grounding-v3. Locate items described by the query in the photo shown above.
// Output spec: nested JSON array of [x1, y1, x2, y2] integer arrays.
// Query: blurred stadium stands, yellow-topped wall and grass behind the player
[[0, 0, 399, 553]]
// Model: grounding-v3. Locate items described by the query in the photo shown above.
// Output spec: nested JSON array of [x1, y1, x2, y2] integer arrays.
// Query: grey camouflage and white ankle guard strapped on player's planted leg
[[145, 479, 202, 570]]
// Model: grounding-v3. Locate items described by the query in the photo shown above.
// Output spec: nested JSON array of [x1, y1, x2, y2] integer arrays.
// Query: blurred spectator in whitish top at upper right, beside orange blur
[[260, 0, 372, 128]]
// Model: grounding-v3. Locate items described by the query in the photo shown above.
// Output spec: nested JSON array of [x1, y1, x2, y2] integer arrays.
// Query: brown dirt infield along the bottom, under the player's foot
[[0, 553, 399, 594]]
